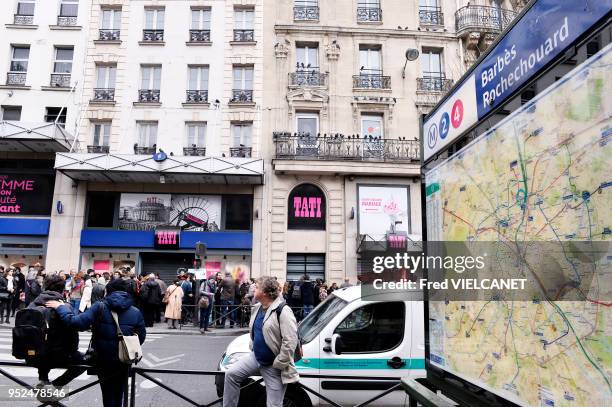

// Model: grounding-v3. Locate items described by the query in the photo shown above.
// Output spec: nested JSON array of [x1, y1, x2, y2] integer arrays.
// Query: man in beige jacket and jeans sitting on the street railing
[[223, 277, 299, 407]]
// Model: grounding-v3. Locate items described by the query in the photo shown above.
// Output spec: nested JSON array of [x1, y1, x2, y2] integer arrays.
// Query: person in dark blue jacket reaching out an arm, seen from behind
[[45, 279, 146, 407]]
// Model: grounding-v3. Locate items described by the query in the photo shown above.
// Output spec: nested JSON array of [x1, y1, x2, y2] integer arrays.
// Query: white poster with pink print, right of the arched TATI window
[[358, 185, 410, 240]]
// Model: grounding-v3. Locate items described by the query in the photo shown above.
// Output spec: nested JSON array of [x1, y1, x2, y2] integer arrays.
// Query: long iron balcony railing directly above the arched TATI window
[[273, 132, 420, 161]]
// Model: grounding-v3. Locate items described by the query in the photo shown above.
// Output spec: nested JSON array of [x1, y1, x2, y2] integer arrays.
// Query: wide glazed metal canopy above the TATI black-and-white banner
[[55, 153, 264, 185]]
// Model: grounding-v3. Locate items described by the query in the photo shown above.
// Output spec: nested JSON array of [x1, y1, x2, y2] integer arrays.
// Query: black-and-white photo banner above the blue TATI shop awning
[[119, 193, 221, 232]]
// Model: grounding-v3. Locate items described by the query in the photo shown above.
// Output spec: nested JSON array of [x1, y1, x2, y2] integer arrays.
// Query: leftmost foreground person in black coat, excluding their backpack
[[28, 274, 86, 387]]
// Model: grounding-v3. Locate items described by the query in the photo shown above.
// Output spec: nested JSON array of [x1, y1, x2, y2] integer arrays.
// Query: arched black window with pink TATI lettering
[[287, 184, 326, 230]]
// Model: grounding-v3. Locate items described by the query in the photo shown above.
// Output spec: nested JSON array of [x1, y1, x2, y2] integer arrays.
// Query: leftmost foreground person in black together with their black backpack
[[13, 274, 85, 387]]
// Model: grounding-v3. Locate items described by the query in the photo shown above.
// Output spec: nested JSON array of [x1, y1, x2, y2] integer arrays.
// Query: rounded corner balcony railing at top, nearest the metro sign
[[455, 6, 517, 35]]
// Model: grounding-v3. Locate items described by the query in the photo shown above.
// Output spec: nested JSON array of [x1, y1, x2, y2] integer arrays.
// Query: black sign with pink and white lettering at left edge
[[0, 173, 55, 216]]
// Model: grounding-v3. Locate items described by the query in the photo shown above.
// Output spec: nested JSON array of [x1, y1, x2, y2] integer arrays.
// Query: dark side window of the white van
[[334, 302, 406, 354]]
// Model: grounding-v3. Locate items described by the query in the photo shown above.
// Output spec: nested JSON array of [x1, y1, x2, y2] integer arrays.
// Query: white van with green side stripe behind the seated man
[[216, 287, 425, 407]]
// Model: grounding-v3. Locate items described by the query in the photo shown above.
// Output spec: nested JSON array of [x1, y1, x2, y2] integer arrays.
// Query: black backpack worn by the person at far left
[[13, 306, 51, 365]]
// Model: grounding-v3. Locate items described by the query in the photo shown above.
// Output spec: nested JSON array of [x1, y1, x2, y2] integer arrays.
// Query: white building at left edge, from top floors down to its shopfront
[[0, 0, 89, 270]]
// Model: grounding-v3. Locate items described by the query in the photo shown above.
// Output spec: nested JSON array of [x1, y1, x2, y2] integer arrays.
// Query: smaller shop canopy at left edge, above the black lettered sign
[[0, 120, 74, 153]]
